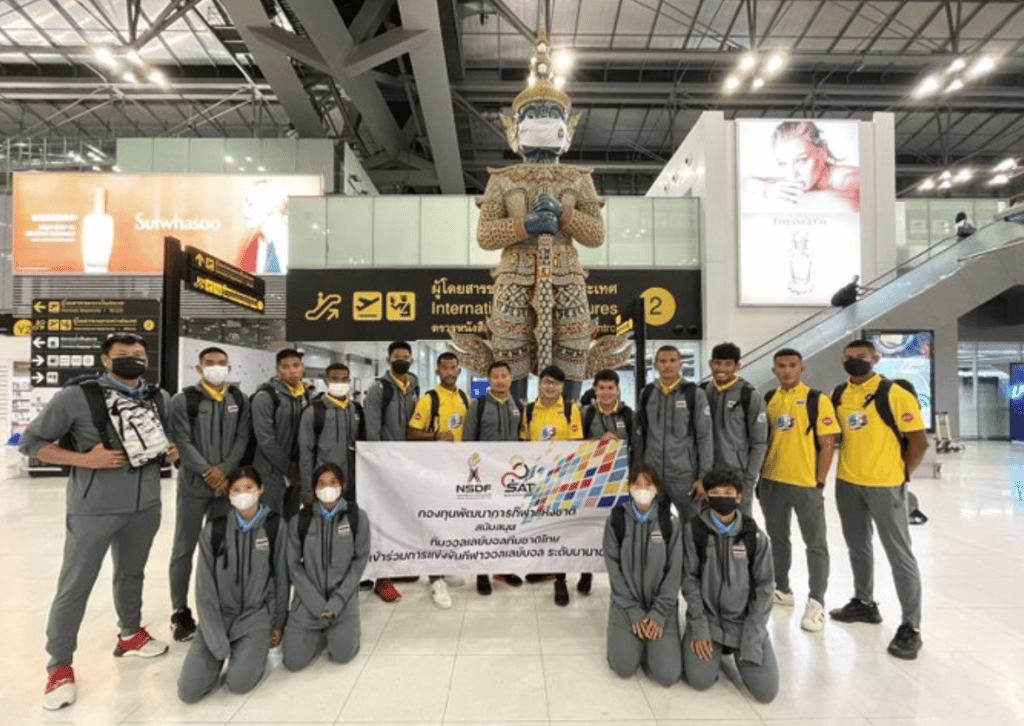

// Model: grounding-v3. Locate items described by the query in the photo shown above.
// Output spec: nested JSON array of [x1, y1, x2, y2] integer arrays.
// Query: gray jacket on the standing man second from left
[[168, 383, 251, 498]]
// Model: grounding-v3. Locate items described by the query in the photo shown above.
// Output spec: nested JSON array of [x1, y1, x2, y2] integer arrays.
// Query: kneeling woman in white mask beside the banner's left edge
[[285, 463, 370, 671]]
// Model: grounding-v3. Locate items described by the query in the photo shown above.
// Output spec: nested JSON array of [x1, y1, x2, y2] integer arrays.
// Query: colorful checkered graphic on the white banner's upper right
[[523, 440, 630, 523]]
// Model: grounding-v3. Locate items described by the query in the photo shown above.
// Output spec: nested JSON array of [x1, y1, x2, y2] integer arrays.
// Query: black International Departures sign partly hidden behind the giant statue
[[286, 267, 701, 341]]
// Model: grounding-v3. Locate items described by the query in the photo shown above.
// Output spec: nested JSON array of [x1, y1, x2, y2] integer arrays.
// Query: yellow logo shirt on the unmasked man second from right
[[761, 383, 840, 486]]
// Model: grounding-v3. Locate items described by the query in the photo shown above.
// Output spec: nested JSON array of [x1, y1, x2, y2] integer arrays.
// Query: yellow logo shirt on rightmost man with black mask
[[836, 374, 925, 486]]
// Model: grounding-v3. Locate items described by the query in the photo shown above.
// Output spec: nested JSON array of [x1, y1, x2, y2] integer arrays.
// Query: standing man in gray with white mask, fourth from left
[[299, 364, 365, 504]]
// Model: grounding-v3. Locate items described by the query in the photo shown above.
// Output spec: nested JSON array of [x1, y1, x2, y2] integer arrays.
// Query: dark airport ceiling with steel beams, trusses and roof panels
[[0, 0, 1024, 196]]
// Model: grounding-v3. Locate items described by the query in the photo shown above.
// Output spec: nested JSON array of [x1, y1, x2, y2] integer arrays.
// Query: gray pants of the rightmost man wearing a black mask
[[836, 479, 921, 628]]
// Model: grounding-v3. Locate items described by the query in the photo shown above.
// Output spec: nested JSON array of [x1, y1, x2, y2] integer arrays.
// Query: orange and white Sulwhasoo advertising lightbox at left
[[13, 173, 323, 274]]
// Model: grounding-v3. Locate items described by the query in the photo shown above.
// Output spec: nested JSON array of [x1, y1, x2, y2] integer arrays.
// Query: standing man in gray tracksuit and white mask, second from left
[[169, 347, 251, 641]]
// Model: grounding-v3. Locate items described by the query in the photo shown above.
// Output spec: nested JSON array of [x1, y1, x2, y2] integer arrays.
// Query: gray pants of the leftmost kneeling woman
[[178, 628, 270, 703]]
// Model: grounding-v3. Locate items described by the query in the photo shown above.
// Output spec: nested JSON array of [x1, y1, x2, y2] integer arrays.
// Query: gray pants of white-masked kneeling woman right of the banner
[[607, 605, 683, 687]]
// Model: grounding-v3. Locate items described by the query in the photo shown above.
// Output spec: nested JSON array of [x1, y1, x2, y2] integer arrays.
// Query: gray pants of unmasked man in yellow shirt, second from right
[[759, 479, 828, 605]]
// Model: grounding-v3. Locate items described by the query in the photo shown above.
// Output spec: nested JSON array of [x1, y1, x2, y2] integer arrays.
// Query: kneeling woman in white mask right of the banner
[[604, 466, 683, 687]]
